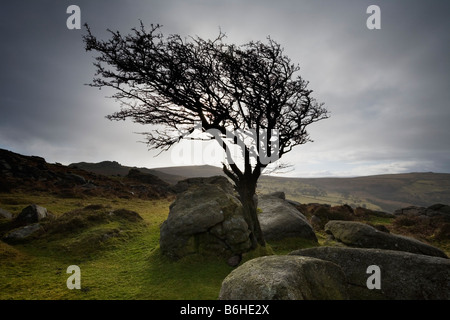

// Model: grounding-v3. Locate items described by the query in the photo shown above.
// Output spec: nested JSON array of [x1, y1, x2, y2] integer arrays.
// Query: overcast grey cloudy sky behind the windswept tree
[[0, 0, 450, 177]]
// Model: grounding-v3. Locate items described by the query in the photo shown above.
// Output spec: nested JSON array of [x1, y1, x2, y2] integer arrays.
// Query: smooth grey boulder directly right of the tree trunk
[[258, 194, 317, 242]]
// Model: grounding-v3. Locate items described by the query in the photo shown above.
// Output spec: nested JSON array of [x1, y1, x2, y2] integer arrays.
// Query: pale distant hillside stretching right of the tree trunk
[[258, 172, 450, 212]]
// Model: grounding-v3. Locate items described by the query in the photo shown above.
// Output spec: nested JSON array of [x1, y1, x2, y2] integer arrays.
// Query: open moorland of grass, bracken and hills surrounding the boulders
[[0, 150, 450, 300]]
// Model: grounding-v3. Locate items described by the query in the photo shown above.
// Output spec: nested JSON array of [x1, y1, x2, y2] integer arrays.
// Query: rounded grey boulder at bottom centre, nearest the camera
[[219, 256, 347, 300]]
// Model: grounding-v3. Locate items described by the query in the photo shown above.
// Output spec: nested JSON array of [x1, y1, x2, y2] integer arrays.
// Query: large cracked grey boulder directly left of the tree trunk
[[160, 179, 251, 259]]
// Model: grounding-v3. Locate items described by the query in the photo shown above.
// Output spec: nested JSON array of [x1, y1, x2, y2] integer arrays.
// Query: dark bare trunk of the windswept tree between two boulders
[[237, 181, 266, 249]]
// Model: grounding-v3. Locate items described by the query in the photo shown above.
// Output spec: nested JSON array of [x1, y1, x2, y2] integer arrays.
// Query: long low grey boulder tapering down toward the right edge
[[325, 220, 447, 258]]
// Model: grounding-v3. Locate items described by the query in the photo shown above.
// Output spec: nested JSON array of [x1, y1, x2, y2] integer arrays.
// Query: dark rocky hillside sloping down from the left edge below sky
[[0, 149, 171, 199]]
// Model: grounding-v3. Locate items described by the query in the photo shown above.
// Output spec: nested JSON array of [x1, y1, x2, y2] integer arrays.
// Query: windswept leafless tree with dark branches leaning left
[[83, 22, 328, 247]]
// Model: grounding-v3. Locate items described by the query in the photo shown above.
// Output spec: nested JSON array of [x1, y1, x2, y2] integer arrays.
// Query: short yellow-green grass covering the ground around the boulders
[[0, 194, 450, 300]]
